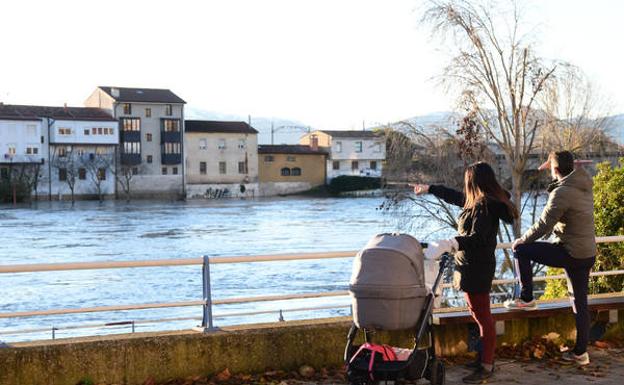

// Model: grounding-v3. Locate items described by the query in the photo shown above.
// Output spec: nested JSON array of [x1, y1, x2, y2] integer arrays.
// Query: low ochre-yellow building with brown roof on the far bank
[[258, 144, 328, 196]]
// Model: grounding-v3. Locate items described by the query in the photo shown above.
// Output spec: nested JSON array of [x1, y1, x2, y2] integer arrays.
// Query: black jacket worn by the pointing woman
[[429, 185, 513, 293]]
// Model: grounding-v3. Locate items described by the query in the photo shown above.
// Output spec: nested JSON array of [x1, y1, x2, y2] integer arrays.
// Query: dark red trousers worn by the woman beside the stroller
[[465, 293, 496, 364]]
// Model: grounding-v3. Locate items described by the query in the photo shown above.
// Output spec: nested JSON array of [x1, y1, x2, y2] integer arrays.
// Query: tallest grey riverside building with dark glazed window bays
[[85, 86, 186, 197]]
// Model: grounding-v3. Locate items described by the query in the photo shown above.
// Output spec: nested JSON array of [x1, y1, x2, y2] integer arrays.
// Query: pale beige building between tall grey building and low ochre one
[[184, 120, 258, 198]]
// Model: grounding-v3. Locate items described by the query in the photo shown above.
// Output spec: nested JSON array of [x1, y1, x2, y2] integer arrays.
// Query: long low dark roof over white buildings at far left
[[0, 104, 117, 121]]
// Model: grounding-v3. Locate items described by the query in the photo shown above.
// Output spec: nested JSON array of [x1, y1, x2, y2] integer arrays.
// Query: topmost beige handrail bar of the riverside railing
[[0, 235, 624, 274]]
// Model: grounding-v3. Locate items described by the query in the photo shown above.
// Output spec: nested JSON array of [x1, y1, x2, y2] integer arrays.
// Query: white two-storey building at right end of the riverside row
[[300, 130, 386, 183]]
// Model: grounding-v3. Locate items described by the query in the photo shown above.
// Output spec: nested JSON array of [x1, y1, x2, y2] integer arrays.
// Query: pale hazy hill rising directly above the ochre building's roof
[[185, 106, 314, 144]]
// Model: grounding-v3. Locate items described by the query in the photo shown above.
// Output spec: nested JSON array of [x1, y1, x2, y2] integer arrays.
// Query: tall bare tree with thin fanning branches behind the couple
[[423, 0, 557, 237]]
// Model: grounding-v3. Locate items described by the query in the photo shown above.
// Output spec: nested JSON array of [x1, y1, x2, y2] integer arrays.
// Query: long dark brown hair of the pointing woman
[[464, 162, 519, 219]]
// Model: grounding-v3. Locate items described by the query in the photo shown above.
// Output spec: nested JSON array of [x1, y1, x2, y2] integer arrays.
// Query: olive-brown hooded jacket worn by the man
[[521, 168, 596, 259]]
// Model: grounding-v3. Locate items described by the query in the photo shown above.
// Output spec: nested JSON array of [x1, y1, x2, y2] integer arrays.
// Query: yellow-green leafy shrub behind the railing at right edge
[[544, 158, 624, 298]]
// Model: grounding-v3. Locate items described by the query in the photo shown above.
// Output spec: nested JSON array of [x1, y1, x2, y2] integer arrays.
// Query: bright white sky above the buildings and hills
[[0, 0, 624, 129]]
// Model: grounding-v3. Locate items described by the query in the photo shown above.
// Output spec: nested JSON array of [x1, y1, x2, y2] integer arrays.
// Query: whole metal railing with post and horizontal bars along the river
[[0, 236, 624, 337]]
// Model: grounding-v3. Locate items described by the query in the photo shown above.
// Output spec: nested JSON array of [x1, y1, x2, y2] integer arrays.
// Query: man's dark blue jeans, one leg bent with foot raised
[[514, 242, 596, 354]]
